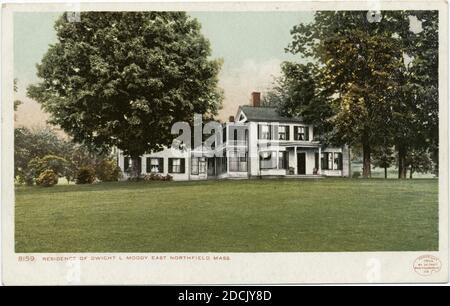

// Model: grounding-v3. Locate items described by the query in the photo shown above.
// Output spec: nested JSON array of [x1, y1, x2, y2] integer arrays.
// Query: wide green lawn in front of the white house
[[16, 179, 438, 252]]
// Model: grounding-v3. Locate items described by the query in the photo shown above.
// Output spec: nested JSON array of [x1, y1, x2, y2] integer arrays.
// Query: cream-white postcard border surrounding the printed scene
[[1, 1, 448, 285]]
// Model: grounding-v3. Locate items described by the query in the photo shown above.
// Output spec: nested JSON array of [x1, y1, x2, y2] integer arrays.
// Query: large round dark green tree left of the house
[[28, 12, 222, 179]]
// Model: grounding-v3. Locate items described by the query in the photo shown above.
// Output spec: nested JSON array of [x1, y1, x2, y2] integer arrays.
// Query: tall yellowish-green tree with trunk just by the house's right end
[[288, 11, 403, 177]]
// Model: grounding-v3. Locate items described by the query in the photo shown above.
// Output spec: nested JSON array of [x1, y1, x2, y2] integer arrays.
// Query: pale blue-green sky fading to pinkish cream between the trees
[[14, 12, 313, 127]]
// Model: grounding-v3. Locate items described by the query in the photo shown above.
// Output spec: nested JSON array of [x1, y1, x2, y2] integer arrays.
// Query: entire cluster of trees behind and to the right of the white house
[[263, 11, 439, 178]]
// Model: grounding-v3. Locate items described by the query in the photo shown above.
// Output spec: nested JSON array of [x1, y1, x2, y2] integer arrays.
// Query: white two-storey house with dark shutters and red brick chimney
[[117, 92, 350, 180]]
